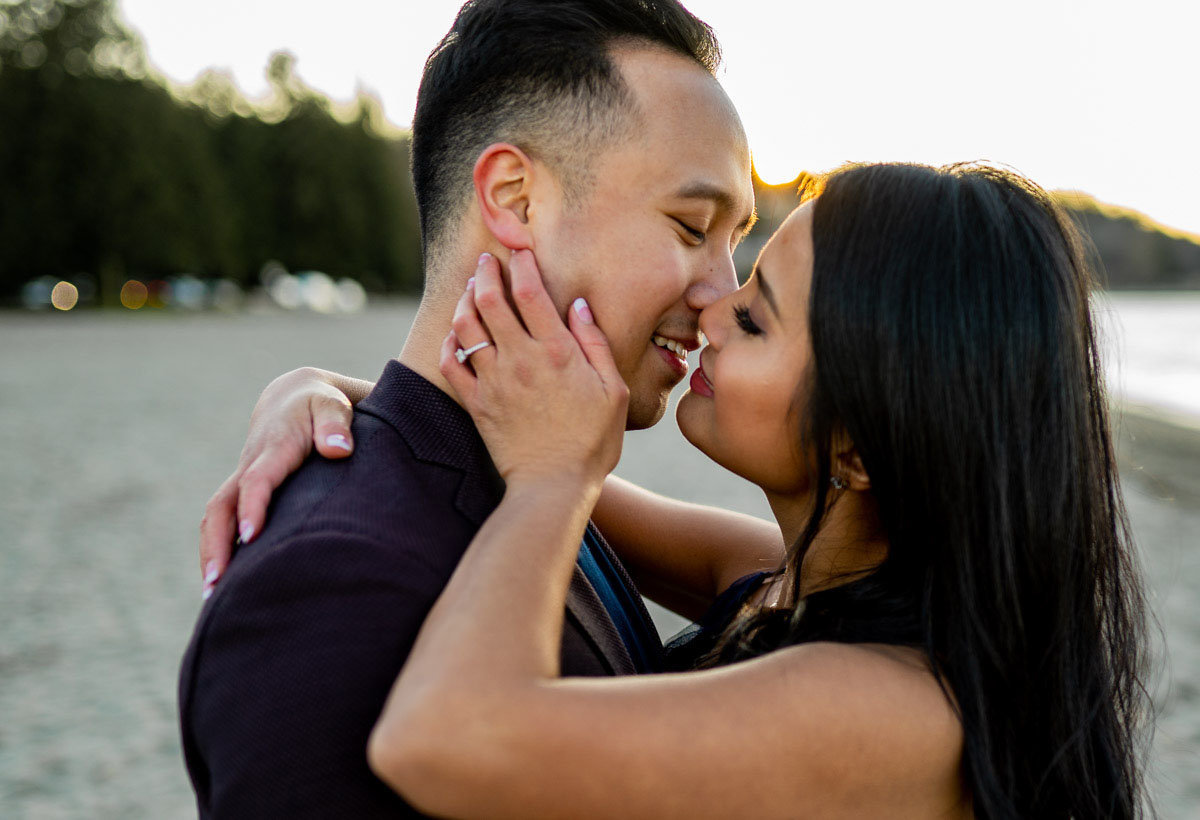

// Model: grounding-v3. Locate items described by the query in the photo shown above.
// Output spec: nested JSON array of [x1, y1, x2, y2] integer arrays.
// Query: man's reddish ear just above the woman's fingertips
[[474, 143, 535, 251]]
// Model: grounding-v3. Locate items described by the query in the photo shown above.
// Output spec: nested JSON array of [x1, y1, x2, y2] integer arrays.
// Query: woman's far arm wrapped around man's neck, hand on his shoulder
[[200, 367, 784, 609]]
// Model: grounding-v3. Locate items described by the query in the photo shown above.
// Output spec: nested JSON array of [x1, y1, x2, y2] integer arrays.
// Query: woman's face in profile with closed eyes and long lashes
[[677, 202, 812, 496]]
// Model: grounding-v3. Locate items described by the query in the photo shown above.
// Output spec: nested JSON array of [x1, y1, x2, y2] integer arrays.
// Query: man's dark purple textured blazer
[[179, 361, 661, 819]]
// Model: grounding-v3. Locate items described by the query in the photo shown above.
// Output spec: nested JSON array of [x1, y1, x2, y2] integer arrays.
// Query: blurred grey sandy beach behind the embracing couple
[[0, 301, 1200, 820]]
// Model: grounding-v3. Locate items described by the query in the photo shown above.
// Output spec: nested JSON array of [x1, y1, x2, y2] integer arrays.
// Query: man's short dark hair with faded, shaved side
[[412, 0, 721, 257]]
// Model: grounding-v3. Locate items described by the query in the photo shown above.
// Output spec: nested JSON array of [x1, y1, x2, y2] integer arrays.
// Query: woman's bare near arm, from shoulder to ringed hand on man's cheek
[[367, 253, 960, 819]]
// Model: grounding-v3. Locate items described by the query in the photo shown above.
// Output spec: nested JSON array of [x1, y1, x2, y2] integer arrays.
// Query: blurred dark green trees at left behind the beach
[[0, 0, 421, 299]]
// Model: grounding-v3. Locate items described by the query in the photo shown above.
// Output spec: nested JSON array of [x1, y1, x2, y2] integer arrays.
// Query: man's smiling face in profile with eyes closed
[[535, 48, 754, 430]]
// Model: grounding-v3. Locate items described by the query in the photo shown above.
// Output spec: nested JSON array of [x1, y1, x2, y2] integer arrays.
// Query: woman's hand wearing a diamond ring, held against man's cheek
[[440, 251, 629, 491]]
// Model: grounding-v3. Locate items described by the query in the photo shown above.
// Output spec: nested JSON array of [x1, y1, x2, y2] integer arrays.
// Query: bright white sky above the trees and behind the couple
[[120, 0, 1200, 234]]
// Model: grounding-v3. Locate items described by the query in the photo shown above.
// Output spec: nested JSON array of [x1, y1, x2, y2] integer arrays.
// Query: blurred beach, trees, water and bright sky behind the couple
[[0, 0, 1200, 818]]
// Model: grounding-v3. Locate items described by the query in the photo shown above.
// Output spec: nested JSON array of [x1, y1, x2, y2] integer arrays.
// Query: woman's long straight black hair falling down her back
[[712, 164, 1147, 818]]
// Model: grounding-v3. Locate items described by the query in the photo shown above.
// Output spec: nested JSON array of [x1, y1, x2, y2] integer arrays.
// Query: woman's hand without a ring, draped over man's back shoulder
[[200, 367, 360, 598]]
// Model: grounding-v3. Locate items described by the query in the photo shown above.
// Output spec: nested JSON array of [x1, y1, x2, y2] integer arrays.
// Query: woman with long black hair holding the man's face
[[194, 166, 1146, 818]]
